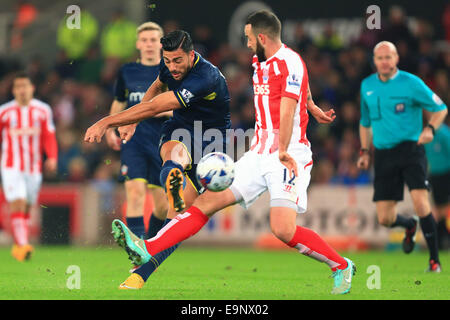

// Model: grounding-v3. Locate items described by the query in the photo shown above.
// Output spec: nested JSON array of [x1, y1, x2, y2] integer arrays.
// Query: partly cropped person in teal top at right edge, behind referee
[[425, 123, 450, 249]]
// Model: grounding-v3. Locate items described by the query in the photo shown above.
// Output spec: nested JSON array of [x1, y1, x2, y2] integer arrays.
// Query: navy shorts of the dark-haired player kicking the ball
[[159, 119, 228, 193]]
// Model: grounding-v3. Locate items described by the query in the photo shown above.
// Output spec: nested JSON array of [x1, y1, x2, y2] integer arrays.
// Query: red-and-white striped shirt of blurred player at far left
[[0, 99, 58, 173]]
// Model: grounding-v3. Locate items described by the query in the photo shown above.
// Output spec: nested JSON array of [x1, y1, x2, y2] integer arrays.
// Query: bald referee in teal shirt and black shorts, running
[[357, 41, 447, 272]]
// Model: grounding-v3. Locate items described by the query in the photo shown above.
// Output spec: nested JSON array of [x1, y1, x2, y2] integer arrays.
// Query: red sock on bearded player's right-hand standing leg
[[287, 226, 347, 271]]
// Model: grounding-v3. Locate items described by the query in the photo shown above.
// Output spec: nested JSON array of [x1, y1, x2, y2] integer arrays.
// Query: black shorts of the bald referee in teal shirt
[[373, 141, 428, 201]]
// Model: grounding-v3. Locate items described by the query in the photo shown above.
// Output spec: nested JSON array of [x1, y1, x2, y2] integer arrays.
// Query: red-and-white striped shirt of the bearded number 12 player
[[250, 44, 310, 154]]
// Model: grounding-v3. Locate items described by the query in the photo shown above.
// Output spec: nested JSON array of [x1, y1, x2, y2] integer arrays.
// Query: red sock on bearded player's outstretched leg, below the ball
[[145, 206, 209, 256]]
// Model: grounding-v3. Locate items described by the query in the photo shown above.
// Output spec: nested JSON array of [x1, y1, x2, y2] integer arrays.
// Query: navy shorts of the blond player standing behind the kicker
[[120, 125, 162, 187]]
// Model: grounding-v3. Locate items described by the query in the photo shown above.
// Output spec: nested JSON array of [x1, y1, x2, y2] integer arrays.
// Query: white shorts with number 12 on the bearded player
[[230, 145, 312, 213]]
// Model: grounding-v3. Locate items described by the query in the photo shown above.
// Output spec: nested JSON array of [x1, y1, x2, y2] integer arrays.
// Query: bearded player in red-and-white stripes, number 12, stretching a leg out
[[108, 11, 355, 294]]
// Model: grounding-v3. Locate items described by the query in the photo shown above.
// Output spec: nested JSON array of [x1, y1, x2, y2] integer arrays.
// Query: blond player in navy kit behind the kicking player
[[106, 22, 168, 262]]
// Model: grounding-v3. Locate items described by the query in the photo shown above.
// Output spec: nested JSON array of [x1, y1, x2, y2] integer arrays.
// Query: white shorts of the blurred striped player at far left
[[2, 169, 42, 204]]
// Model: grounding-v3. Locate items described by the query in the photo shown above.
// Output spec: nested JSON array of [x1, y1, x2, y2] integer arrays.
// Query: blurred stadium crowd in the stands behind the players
[[0, 3, 450, 189]]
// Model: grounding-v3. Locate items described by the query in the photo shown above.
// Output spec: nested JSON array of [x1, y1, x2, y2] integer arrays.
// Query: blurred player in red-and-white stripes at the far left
[[0, 73, 58, 261]]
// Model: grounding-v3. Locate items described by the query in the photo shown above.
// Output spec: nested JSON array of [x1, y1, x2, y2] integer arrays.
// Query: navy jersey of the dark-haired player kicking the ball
[[159, 52, 231, 130]]
